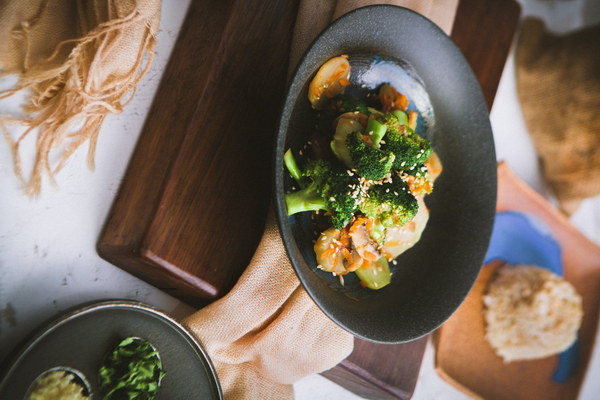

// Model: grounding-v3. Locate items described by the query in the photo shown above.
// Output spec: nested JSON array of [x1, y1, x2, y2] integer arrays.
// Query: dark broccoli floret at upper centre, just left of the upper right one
[[346, 134, 395, 181]]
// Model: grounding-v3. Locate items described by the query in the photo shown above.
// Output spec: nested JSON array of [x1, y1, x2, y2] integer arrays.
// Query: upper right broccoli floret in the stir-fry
[[381, 128, 433, 174]]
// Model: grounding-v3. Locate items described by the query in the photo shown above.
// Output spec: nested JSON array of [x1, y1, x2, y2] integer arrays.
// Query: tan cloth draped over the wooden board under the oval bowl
[[184, 0, 458, 400]]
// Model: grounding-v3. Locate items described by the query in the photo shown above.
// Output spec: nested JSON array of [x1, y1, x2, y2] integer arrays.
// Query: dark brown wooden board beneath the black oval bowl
[[98, 0, 519, 398]]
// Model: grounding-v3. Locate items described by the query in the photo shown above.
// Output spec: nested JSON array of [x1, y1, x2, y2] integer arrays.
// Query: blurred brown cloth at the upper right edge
[[515, 19, 600, 214]]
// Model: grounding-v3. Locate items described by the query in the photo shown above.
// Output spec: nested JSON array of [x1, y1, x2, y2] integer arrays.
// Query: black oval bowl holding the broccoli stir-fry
[[274, 6, 496, 343]]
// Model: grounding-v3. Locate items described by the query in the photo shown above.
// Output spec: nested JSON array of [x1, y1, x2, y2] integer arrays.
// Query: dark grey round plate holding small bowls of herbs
[[0, 300, 223, 400]]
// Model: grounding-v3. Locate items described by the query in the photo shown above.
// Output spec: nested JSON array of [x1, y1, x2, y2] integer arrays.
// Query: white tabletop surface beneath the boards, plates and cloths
[[0, 0, 600, 400]]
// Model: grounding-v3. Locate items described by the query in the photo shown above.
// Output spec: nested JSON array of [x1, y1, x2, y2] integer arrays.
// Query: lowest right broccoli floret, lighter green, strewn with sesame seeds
[[359, 176, 419, 227]]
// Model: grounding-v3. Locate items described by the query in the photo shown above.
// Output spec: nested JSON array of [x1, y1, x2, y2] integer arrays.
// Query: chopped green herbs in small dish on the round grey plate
[[99, 337, 165, 400]]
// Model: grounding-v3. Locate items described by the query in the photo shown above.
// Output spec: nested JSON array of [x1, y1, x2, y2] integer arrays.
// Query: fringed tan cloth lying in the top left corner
[[0, 0, 161, 195]]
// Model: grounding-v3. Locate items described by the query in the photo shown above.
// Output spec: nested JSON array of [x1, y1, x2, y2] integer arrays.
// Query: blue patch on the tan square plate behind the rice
[[485, 211, 579, 382]]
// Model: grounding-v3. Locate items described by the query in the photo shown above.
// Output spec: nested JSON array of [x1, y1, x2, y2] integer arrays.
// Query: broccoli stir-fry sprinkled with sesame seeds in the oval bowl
[[284, 56, 442, 289]]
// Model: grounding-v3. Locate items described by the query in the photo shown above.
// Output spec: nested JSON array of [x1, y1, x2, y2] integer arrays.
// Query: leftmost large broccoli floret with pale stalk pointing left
[[285, 155, 361, 229]]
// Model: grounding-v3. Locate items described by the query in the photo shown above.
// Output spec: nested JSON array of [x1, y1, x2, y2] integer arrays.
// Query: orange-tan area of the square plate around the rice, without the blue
[[435, 163, 600, 400]]
